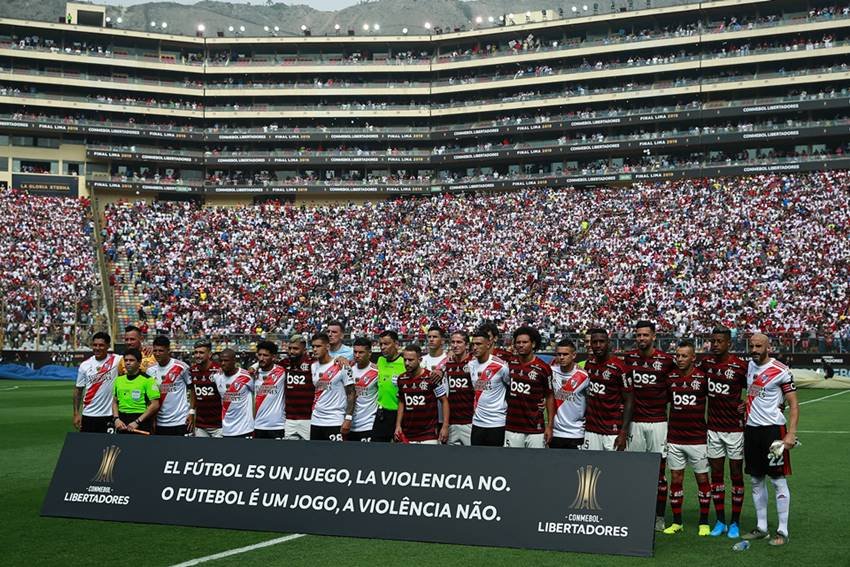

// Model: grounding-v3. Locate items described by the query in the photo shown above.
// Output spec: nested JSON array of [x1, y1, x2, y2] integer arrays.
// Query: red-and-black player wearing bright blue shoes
[[700, 327, 747, 539]]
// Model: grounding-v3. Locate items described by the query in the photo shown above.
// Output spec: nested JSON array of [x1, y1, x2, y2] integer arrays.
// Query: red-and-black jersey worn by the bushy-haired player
[[505, 356, 552, 433]]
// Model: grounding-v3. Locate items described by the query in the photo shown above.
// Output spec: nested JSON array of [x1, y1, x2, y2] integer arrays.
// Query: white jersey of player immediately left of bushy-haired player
[[468, 355, 511, 428]]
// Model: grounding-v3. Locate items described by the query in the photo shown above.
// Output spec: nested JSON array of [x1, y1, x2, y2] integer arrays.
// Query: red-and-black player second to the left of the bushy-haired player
[[443, 331, 475, 446]]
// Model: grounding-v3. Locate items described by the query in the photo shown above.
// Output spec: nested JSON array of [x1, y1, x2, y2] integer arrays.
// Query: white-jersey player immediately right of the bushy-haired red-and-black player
[[549, 339, 590, 449]]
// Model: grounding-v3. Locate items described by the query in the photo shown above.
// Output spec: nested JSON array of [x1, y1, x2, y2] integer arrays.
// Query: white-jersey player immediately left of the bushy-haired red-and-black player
[[469, 328, 511, 447]]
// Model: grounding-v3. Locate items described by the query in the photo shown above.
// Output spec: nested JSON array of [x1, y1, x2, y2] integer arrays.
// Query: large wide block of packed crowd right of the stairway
[[104, 171, 850, 346]]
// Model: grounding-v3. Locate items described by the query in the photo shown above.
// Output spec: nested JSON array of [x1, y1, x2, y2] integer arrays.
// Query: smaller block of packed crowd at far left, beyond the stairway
[[0, 190, 98, 349]]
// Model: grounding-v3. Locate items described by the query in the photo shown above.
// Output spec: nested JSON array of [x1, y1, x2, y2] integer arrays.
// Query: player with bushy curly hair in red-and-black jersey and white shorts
[[505, 327, 555, 449]]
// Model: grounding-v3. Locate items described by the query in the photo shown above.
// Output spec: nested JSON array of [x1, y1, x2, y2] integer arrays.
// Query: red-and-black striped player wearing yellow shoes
[[664, 341, 711, 536]]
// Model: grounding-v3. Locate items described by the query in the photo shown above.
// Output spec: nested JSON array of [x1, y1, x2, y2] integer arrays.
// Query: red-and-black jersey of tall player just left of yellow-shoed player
[[623, 349, 676, 423]]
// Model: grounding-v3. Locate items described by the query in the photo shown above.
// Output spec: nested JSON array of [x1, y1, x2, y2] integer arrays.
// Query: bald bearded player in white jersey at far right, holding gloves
[[743, 333, 800, 546]]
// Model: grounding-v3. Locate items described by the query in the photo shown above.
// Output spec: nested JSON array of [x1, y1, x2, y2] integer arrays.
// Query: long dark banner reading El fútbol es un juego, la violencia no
[[42, 433, 659, 556]]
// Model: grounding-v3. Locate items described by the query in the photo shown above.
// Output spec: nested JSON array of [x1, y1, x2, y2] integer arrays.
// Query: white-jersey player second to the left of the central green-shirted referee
[[310, 333, 357, 441]]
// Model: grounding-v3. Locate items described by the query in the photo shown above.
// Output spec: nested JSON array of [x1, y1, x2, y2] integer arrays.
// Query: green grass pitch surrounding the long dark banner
[[0, 380, 850, 567]]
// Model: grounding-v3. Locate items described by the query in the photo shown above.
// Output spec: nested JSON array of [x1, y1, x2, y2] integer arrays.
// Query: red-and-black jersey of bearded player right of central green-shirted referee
[[398, 369, 451, 441]]
